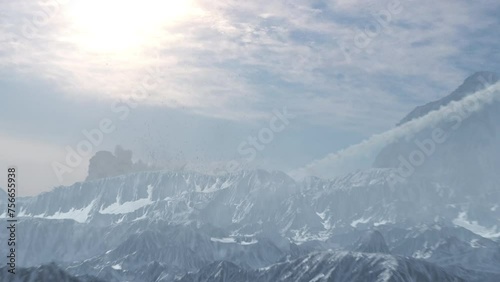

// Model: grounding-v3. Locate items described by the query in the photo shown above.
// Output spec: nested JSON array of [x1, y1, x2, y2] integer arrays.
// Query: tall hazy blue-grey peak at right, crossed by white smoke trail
[[374, 72, 500, 176]]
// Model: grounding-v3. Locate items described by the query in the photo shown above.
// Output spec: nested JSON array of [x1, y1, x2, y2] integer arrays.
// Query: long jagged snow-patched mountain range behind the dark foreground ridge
[[0, 166, 500, 281]]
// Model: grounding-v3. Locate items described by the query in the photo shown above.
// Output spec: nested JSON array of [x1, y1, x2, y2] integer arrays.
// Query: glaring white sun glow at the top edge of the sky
[[68, 0, 194, 52]]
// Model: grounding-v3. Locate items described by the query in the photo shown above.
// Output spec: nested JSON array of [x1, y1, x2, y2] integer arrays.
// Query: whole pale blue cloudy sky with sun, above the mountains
[[0, 0, 500, 195]]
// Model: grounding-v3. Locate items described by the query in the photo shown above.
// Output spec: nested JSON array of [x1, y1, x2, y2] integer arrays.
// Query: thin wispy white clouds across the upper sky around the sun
[[0, 0, 498, 130]]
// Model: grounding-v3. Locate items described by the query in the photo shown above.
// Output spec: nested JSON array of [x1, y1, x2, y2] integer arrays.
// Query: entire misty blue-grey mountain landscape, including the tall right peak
[[0, 72, 500, 282]]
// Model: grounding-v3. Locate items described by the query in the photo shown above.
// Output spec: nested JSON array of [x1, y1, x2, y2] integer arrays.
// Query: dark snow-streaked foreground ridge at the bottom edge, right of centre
[[177, 252, 465, 282]]
